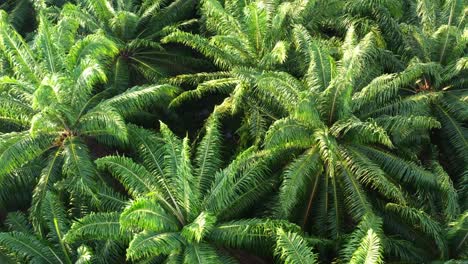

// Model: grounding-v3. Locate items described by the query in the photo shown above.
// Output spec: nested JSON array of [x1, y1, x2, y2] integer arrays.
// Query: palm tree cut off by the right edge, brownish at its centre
[[401, 0, 468, 206]]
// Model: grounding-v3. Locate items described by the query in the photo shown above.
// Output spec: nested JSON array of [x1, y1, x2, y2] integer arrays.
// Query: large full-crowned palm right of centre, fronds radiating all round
[[257, 26, 459, 256]]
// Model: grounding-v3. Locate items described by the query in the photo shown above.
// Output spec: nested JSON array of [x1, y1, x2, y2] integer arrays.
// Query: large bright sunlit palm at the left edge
[[0, 12, 177, 228]]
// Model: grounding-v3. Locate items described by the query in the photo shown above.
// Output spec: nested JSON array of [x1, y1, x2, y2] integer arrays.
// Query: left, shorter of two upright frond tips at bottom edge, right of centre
[[275, 228, 317, 264]]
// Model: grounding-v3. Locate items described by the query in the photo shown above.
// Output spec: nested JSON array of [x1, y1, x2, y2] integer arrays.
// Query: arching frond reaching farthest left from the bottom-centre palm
[[64, 212, 129, 243]]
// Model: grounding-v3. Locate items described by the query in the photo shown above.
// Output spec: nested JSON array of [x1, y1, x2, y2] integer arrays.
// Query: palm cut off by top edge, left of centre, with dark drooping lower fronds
[[62, 0, 204, 92]]
